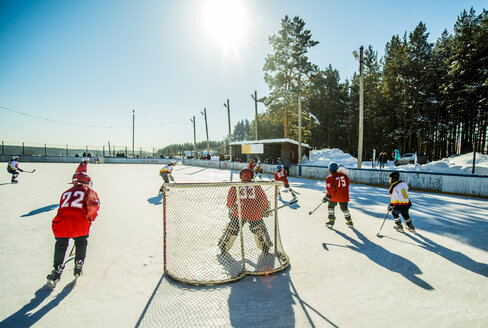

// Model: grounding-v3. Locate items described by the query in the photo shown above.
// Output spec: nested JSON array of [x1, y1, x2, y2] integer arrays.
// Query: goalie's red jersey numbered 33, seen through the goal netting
[[227, 186, 269, 221]]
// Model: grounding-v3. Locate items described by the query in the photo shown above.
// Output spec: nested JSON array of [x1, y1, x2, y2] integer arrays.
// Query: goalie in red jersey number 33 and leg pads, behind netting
[[218, 168, 273, 254]]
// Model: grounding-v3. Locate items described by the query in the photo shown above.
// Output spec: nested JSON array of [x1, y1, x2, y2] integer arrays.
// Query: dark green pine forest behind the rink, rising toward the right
[[160, 9, 488, 160]]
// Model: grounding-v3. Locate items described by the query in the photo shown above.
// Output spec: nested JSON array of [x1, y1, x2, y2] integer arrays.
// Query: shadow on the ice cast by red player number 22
[[0, 280, 75, 328]]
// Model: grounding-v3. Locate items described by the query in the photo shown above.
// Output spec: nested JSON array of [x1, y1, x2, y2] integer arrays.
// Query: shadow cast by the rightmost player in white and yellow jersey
[[407, 233, 488, 277]]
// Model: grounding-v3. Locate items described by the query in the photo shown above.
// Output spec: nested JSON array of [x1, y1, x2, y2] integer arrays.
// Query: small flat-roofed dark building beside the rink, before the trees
[[230, 138, 310, 164]]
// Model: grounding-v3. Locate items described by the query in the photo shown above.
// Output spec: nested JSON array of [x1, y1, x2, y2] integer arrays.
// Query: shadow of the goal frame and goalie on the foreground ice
[[136, 261, 338, 328]]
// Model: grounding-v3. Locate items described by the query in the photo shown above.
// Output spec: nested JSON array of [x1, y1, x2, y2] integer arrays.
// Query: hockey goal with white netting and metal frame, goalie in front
[[163, 182, 289, 285]]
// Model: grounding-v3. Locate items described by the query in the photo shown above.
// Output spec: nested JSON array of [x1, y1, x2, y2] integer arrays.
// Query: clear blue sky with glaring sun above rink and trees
[[0, 0, 488, 149]]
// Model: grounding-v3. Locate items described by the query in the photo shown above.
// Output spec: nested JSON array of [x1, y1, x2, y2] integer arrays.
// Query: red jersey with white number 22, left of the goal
[[52, 185, 100, 238]]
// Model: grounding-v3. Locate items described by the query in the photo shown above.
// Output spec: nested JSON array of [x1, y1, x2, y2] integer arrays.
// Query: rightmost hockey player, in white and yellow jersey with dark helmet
[[388, 171, 415, 232]]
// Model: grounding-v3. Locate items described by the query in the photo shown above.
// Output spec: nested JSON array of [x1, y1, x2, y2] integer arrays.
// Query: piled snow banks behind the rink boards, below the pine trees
[[303, 148, 488, 175]]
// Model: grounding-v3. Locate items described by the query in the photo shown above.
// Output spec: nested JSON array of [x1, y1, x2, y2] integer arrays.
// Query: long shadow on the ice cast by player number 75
[[334, 229, 434, 290]]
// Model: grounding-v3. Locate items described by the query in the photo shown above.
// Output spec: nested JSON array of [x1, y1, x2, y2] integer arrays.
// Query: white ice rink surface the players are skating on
[[0, 163, 488, 328]]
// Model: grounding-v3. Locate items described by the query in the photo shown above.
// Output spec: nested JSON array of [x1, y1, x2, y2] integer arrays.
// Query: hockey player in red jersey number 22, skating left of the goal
[[47, 172, 100, 288]]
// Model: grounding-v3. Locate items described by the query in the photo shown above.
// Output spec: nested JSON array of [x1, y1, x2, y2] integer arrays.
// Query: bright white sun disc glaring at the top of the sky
[[202, 0, 248, 51]]
